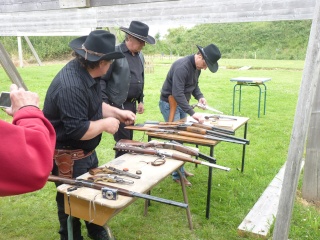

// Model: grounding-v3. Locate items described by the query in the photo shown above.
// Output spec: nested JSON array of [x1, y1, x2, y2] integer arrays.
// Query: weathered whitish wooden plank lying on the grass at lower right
[[238, 161, 303, 238]]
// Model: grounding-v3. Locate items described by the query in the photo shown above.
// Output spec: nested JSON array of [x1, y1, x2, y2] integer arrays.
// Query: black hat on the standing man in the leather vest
[[120, 21, 156, 44]]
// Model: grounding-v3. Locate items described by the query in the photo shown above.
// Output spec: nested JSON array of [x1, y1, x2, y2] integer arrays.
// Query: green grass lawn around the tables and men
[[0, 58, 320, 240]]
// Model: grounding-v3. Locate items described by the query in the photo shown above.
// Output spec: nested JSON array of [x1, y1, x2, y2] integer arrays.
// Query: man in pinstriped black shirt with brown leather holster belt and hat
[[43, 30, 135, 240]]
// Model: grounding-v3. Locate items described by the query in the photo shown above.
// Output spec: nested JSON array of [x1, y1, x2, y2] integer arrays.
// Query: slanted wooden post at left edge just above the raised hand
[[0, 42, 28, 90]]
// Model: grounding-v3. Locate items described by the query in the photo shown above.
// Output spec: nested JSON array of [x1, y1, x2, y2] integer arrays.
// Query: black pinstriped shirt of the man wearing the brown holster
[[43, 60, 102, 151]]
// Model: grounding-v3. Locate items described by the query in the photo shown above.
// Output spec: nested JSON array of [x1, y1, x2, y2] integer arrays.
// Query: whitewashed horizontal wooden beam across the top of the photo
[[0, 0, 315, 36]]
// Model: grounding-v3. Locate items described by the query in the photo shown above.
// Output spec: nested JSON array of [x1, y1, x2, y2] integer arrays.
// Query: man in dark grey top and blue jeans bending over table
[[159, 44, 221, 186]]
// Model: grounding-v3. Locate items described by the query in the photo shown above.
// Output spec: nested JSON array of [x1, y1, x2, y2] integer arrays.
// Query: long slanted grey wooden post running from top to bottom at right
[[273, 0, 320, 240]]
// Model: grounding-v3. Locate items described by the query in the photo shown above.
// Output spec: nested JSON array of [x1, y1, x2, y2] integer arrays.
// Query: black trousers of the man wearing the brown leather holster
[[52, 152, 105, 240]]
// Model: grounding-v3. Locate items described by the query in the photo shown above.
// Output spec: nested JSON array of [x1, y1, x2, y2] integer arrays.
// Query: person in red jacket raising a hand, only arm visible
[[0, 84, 56, 197]]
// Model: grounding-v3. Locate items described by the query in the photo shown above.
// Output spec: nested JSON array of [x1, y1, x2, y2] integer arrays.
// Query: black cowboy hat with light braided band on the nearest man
[[69, 30, 124, 62]]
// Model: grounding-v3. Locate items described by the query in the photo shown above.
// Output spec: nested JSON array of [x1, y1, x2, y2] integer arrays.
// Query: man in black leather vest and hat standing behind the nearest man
[[100, 21, 155, 157]]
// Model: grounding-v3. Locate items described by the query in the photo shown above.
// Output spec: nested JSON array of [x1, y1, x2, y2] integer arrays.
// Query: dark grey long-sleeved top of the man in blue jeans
[[160, 55, 204, 116]]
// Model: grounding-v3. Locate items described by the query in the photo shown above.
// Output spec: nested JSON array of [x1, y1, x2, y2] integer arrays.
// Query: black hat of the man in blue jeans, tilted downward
[[197, 44, 221, 73]]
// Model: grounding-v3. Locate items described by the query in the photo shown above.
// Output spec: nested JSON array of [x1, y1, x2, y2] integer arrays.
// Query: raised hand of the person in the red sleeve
[[5, 84, 39, 116]]
